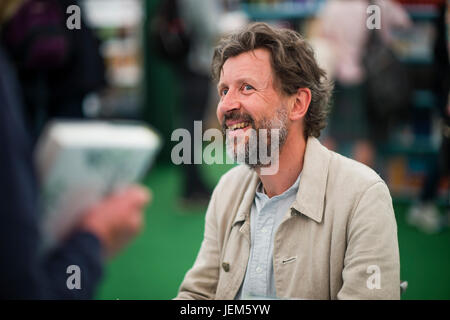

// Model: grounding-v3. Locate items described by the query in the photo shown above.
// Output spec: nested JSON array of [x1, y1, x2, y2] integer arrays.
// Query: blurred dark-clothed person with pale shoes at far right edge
[[407, 3, 450, 233]]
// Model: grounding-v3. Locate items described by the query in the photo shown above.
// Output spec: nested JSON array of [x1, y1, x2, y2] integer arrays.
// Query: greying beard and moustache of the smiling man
[[222, 106, 289, 169]]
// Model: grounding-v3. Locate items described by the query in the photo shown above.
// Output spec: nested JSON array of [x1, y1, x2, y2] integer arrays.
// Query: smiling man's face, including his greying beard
[[217, 48, 290, 176]]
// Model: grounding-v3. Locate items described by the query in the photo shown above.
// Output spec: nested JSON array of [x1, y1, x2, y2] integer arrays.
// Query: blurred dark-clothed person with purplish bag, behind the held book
[[1, 0, 106, 140]]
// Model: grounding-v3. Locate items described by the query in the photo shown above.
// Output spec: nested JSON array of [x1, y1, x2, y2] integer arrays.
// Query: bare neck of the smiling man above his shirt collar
[[256, 132, 306, 198]]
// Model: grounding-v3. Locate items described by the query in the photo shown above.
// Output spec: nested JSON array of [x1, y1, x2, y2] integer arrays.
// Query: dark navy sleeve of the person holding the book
[[0, 47, 102, 299]]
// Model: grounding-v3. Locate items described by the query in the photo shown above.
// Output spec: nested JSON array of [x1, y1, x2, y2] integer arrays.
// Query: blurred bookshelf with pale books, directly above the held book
[[81, 0, 144, 118]]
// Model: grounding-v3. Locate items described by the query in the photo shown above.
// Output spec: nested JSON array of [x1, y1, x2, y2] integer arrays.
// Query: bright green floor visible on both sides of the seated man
[[97, 162, 450, 299]]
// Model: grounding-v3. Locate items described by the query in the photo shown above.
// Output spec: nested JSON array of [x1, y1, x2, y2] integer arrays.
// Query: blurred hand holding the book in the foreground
[[80, 185, 151, 257]]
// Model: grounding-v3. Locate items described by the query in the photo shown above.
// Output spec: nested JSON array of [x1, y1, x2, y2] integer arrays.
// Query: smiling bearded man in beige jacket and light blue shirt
[[177, 23, 400, 299]]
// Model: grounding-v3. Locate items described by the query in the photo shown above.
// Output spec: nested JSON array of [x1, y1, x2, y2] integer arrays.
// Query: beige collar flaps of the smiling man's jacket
[[233, 137, 331, 225]]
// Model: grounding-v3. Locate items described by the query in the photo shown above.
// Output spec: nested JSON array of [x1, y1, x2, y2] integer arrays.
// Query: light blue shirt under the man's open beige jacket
[[236, 173, 301, 299]]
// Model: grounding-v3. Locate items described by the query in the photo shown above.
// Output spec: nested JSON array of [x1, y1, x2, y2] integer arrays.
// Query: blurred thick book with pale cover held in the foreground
[[35, 120, 161, 249]]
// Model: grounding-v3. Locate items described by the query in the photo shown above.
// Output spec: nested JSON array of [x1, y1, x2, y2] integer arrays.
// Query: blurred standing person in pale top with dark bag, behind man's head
[[156, 0, 247, 206]]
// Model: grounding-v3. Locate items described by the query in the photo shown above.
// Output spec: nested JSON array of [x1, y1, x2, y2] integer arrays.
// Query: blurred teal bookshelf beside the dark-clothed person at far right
[[382, 0, 450, 205]]
